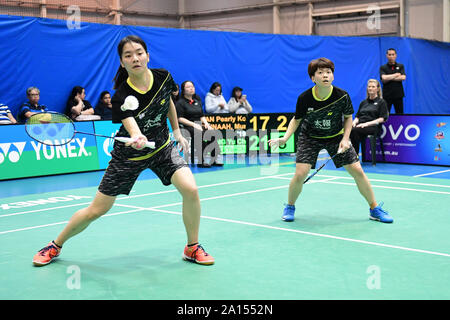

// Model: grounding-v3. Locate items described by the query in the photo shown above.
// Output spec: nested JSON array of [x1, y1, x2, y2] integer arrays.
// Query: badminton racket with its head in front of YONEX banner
[[25, 112, 155, 149]]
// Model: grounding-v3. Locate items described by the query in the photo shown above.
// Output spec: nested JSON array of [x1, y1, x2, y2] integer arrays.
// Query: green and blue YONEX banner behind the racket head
[[0, 122, 98, 180]]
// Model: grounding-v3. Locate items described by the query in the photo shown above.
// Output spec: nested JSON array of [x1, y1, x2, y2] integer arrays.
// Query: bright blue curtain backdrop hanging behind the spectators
[[0, 15, 450, 118]]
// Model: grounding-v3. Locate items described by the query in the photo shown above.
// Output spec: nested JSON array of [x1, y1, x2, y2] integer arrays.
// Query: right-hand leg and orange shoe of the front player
[[171, 167, 214, 265]]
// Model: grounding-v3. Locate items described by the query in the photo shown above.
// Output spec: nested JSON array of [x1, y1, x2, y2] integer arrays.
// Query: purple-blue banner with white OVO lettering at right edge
[[364, 114, 450, 166]]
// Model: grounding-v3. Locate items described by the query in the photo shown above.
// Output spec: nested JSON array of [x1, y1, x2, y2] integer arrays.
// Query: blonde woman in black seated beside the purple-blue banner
[[350, 79, 389, 154]]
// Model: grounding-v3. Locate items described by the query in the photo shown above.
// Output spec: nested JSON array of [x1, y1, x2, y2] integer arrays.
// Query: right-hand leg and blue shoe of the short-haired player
[[344, 161, 394, 223]]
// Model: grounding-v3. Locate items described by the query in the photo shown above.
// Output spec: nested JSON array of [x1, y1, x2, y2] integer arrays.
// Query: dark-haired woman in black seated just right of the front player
[[176, 81, 223, 167]]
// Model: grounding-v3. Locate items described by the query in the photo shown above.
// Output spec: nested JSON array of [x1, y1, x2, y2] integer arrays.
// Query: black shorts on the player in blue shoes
[[295, 134, 359, 169]]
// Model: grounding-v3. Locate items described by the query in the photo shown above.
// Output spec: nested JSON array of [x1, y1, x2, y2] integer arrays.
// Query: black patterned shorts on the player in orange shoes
[[98, 140, 188, 196]]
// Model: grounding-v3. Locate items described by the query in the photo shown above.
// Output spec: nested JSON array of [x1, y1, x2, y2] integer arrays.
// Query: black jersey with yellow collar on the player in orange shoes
[[111, 69, 177, 160]]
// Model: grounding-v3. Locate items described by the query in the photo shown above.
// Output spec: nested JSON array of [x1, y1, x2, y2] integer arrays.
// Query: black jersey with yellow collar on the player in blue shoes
[[295, 86, 354, 138]]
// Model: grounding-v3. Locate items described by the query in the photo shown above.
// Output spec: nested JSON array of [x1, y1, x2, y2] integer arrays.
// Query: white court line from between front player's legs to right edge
[[117, 205, 450, 257]]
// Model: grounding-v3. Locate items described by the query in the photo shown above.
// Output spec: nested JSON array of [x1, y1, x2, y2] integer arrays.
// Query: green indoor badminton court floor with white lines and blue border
[[0, 156, 450, 300]]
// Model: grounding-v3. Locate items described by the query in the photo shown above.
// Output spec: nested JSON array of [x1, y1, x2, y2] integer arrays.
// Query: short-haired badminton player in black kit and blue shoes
[[269, 58, 393, 223]]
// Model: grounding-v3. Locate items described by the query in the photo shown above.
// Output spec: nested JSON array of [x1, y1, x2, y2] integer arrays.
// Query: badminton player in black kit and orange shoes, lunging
[[33, 36, 214, 266]]
